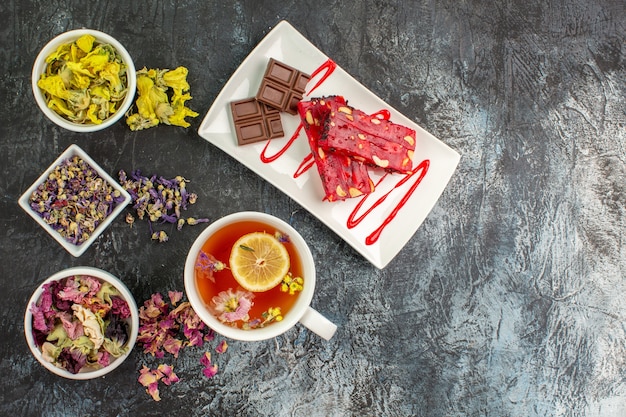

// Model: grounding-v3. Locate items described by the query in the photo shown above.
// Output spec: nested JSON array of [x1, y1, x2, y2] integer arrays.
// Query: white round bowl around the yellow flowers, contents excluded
[[31, 29, 137, 132]]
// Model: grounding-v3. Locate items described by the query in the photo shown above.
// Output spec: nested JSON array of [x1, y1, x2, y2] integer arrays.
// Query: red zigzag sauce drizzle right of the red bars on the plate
[[346, 159, 430, 245]]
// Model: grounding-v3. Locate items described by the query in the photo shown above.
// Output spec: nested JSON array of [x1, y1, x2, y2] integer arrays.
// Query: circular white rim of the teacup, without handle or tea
[[184, 211, 315, 341]]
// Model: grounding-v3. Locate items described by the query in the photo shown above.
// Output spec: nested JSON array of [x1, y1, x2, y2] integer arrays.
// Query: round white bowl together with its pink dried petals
[[24, 267, 139, 380]]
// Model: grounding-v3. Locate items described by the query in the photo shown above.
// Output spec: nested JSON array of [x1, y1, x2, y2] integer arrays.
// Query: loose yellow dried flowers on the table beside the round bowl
[[126, 67, 198, 130]]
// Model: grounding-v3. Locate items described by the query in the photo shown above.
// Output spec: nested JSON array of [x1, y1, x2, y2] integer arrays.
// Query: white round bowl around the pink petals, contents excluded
[[24, 267, 139, 380]]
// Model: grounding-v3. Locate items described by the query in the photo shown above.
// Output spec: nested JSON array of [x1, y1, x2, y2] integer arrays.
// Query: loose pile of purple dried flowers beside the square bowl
[[119, 170, 209, 242]]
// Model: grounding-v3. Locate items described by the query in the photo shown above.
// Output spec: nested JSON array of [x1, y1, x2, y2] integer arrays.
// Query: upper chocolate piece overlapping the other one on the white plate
[[256, 58, 311, 115]]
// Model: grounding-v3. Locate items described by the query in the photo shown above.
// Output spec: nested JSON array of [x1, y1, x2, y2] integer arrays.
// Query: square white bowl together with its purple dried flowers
[[19, 145, 131, 257]]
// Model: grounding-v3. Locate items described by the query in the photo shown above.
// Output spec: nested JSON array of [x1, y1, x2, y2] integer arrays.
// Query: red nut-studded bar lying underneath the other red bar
[[298, 97, 374, 201]]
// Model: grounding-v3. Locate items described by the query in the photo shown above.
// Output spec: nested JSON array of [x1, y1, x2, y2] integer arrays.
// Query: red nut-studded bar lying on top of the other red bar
[[318, 100, 415, 173]]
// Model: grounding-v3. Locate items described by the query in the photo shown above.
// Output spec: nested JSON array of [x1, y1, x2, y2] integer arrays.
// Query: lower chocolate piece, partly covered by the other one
[[230, 97, 285, 145]]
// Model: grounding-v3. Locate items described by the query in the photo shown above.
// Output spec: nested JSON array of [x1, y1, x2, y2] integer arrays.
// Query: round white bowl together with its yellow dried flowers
[[32, 29, 137, 132]]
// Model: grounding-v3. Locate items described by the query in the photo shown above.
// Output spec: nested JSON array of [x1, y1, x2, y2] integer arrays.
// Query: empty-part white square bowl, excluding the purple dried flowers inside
[[18, 145, 132, 257]]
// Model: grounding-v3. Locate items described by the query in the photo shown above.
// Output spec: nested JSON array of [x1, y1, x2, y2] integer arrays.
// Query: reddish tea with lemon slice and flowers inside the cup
[[195, 221, 306, 329]]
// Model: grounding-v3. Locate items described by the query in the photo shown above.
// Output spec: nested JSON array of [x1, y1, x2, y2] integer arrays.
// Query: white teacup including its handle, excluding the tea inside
[[184, 212, 337, 341]]
